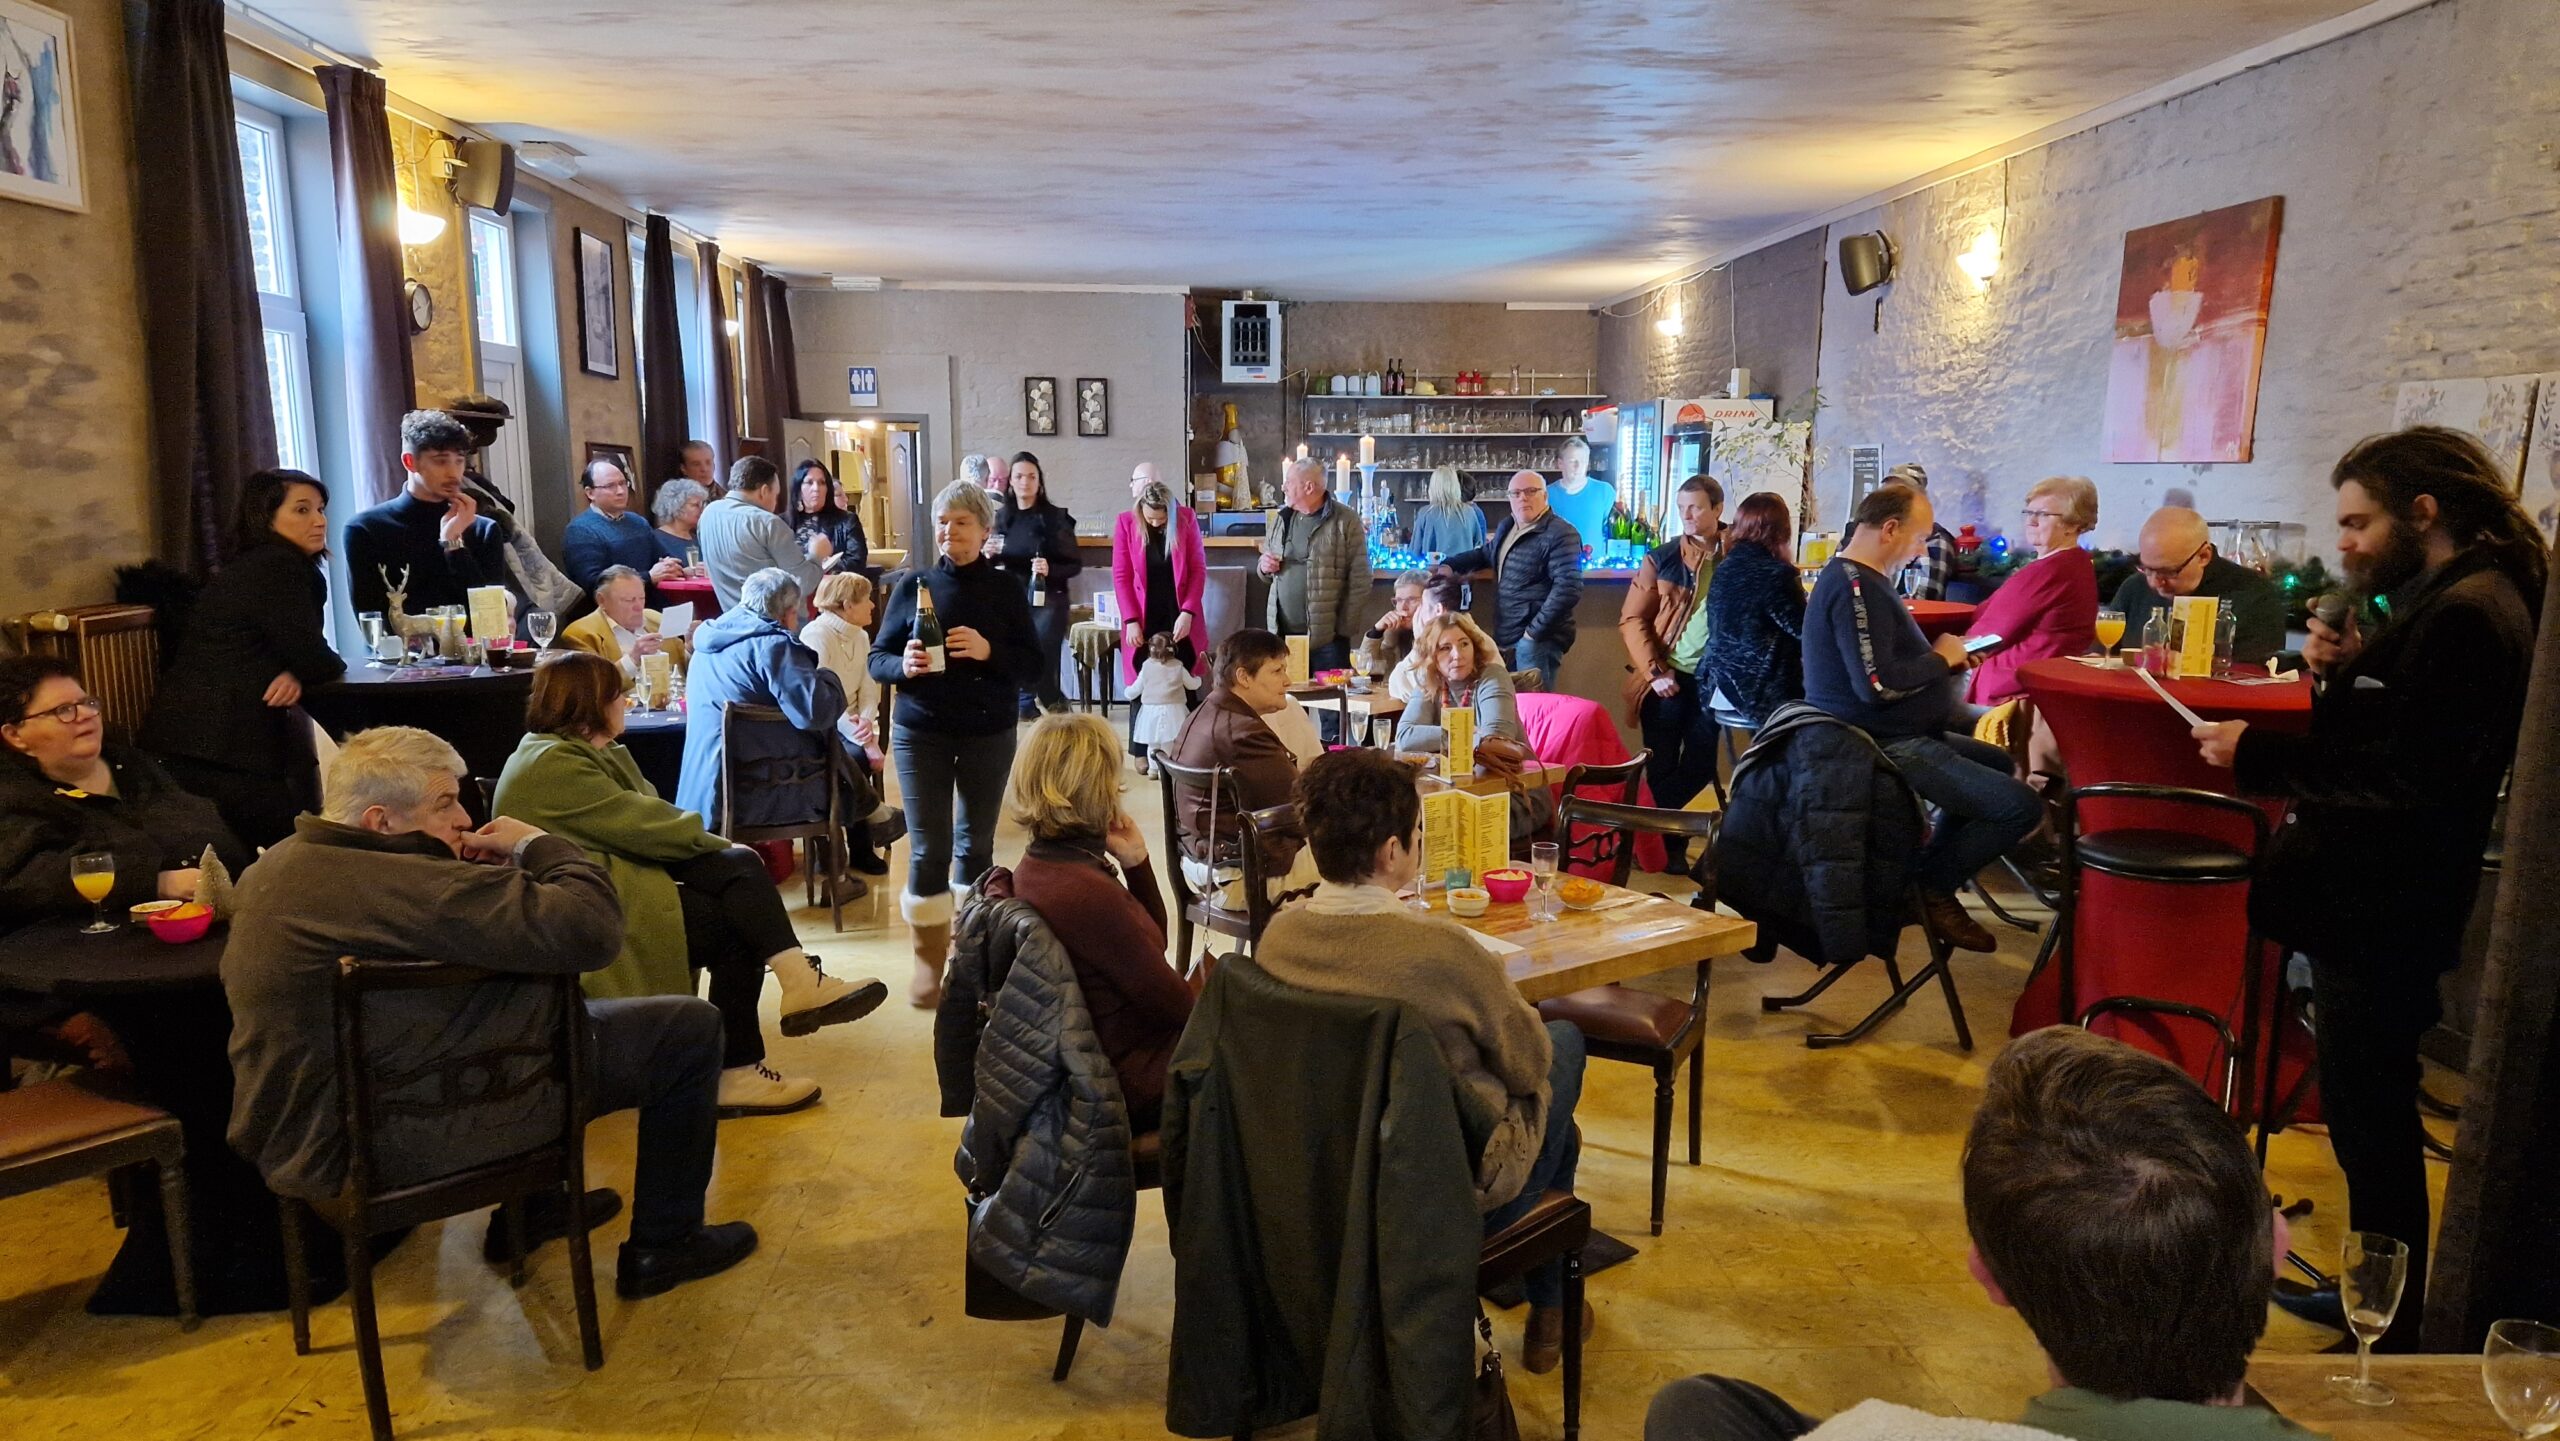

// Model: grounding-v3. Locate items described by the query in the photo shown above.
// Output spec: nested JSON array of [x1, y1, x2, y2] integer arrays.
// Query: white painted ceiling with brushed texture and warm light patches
[[256, 0, 2353, 302]]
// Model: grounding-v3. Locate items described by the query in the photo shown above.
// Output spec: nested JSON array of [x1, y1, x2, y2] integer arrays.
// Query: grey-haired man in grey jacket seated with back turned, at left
[[223, 727, 755, 1298]]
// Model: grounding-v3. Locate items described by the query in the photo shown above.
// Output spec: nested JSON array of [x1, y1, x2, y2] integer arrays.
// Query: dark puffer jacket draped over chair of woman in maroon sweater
[[934, 868, 1137, 1326]]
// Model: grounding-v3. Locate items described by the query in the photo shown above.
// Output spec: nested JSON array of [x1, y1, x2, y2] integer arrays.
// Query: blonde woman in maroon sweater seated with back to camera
[[1004, 712, 1193, 1131]]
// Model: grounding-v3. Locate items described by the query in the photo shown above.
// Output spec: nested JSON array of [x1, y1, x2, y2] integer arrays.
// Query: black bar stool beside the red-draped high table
[[2053, 781, 2273, 1165]]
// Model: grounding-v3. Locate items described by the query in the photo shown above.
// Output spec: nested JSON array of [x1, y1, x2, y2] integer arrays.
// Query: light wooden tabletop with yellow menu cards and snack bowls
[[1431, 880, 1759, 1003]]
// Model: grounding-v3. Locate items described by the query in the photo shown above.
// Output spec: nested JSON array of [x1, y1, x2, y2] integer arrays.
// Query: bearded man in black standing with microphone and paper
[[2196, 425, 2550, 1351]]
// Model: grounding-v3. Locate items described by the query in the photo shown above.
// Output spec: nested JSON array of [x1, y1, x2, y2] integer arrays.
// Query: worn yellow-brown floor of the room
[[0, 762, 2442, 1441]]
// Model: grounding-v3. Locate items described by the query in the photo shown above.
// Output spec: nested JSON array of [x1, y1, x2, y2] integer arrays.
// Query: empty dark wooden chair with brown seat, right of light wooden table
[[1539, 793, 1718, 1236]]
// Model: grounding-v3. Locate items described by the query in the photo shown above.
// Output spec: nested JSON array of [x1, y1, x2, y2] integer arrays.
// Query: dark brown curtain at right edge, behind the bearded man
[[2424, 537, 2560, 1351]]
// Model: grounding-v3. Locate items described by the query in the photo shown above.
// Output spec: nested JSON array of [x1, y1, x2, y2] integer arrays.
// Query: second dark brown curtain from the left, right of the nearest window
[[312, 64, 417, 504]]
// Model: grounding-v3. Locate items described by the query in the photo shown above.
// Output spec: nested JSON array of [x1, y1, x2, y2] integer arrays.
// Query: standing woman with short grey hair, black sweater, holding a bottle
[[870, 476, 1044, 1011]]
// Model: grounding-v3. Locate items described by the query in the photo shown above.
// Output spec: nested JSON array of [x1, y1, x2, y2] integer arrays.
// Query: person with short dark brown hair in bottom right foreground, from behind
[[1644, 1026, 2317, 1441]]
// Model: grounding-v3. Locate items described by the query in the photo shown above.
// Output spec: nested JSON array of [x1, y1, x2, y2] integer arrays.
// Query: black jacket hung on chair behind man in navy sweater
[[1715, 701, 1928, 965]]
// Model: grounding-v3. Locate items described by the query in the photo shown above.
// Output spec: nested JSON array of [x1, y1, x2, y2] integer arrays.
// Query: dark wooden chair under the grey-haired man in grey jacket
[[282, 957, 604, 1441]]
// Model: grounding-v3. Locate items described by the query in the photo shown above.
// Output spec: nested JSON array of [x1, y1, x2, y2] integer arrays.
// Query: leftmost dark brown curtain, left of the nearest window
[[125, 0, 276, 576]]
